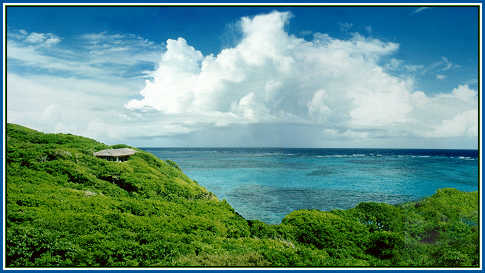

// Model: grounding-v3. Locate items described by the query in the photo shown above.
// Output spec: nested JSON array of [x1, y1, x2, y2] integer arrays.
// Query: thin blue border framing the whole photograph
[[0, 0, 485, 273]]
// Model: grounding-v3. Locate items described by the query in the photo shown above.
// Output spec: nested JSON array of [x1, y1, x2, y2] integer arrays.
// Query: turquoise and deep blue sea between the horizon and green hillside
[[143, 148, 478, 224]]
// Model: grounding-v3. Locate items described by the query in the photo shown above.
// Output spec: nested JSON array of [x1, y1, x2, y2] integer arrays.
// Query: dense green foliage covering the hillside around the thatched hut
[[6, 124, 479, 267]]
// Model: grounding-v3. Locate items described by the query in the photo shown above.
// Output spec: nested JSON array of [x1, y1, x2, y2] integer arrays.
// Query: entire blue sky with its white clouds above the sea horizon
[[6, 6, 478, 149]]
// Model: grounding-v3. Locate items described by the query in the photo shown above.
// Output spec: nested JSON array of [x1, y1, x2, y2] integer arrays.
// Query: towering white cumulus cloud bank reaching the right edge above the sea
[[125, 12, 478, 142]]
